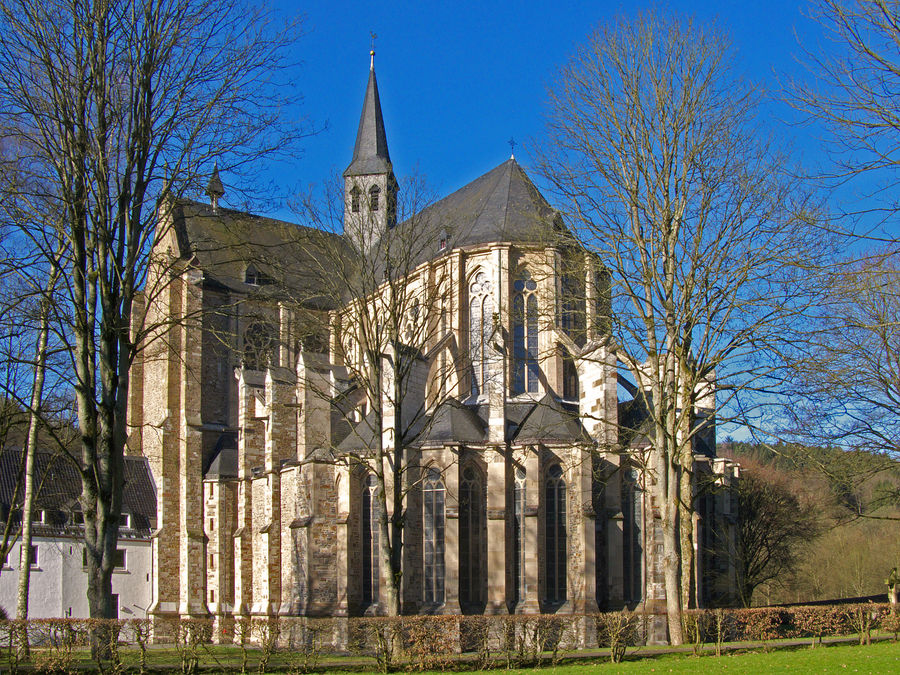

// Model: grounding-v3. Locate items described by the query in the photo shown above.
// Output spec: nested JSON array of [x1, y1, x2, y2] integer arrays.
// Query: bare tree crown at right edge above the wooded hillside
[[779, 253, 900, 519]]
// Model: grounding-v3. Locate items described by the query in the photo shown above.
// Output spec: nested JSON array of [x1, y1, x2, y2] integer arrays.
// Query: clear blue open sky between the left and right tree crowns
[[251, 0, 836, 215]]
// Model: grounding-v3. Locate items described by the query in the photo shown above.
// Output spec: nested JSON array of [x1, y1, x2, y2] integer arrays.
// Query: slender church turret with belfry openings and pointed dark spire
[[344, 49, 397, 253]]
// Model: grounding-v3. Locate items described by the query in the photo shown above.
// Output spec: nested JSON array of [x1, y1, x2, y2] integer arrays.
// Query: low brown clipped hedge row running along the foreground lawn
[[0, 603, 900, 673]]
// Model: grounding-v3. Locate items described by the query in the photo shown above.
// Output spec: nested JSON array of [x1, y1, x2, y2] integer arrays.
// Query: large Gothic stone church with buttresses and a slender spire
[[129, 52, 737, 640]]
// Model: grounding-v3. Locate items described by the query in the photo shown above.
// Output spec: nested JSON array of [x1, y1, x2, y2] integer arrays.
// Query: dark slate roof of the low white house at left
[[0, 448, 156, 536]]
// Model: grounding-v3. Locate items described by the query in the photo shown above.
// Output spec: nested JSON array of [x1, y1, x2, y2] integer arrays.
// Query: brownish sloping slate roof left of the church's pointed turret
[[172, 199, 346, 308]]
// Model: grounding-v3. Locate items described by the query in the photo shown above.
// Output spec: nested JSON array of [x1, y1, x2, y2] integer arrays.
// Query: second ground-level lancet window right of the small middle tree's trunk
[[459, 466, 486, 609]]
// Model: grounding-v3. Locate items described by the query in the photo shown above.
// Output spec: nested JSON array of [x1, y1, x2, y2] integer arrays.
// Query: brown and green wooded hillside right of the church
[[718, 439, 900, 605]]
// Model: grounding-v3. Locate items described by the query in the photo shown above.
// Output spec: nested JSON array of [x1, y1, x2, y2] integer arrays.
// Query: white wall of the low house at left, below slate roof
[[0, 537, 152, 619]]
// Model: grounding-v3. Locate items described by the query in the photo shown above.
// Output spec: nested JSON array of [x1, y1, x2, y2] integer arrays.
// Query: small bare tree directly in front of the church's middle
[[301, 176, 460, 616]]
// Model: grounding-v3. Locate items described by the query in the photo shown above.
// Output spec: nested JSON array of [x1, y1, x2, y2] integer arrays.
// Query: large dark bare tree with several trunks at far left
[[0, 0, 299, 628]]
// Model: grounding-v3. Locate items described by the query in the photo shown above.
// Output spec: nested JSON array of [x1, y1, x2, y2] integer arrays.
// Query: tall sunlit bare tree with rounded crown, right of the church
[[540, 14, 821, 644]]
